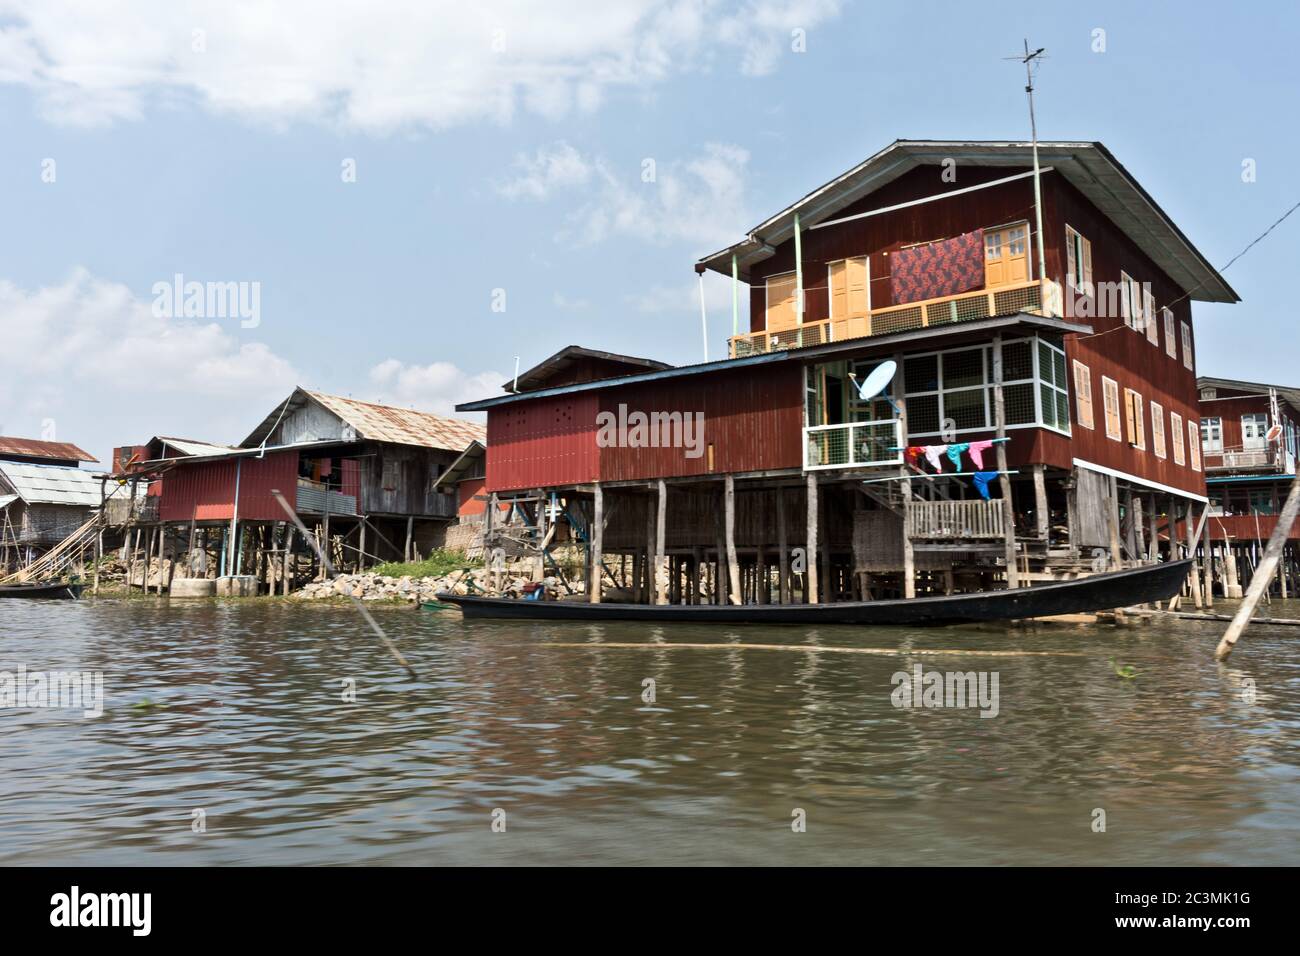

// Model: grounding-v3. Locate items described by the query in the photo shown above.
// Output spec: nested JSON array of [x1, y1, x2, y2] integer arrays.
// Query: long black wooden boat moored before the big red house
[[437, 559, 1192, 627]]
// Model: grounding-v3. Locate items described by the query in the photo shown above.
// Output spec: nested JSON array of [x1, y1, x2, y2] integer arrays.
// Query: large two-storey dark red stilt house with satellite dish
[[460, 140, 1238, 601]]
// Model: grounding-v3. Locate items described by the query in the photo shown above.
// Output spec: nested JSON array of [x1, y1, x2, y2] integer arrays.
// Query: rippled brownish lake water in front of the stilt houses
[[0, 598, 1300, 865]]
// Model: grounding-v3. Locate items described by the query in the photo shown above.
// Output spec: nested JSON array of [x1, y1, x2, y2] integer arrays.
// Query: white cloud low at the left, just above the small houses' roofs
[[0, 269, 298, 463]]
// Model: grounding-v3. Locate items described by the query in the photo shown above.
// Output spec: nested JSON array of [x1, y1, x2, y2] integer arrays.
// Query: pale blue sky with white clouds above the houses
[[0, 0, 1300, 463]]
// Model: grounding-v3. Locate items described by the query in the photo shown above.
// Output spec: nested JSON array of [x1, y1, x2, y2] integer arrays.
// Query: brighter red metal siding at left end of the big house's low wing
[[488, 392, 602, 492]]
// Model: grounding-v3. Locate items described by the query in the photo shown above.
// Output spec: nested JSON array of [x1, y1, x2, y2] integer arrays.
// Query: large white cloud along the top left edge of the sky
[[0, 0, 840, 133]]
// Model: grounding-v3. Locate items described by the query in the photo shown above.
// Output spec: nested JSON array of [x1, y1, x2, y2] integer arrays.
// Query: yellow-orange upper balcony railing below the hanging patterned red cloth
[[731, 280, 1063, 359]]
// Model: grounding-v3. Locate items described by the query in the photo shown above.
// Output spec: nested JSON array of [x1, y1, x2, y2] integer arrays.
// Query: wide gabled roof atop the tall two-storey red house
[[699, 139, 1240, 302]]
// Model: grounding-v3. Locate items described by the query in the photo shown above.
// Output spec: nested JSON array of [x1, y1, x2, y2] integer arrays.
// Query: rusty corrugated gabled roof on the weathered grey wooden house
[[241, 388, 488, 451]]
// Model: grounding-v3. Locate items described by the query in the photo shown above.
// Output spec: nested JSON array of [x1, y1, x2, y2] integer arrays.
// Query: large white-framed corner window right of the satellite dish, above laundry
[[902, 336, 1070, 437]]
